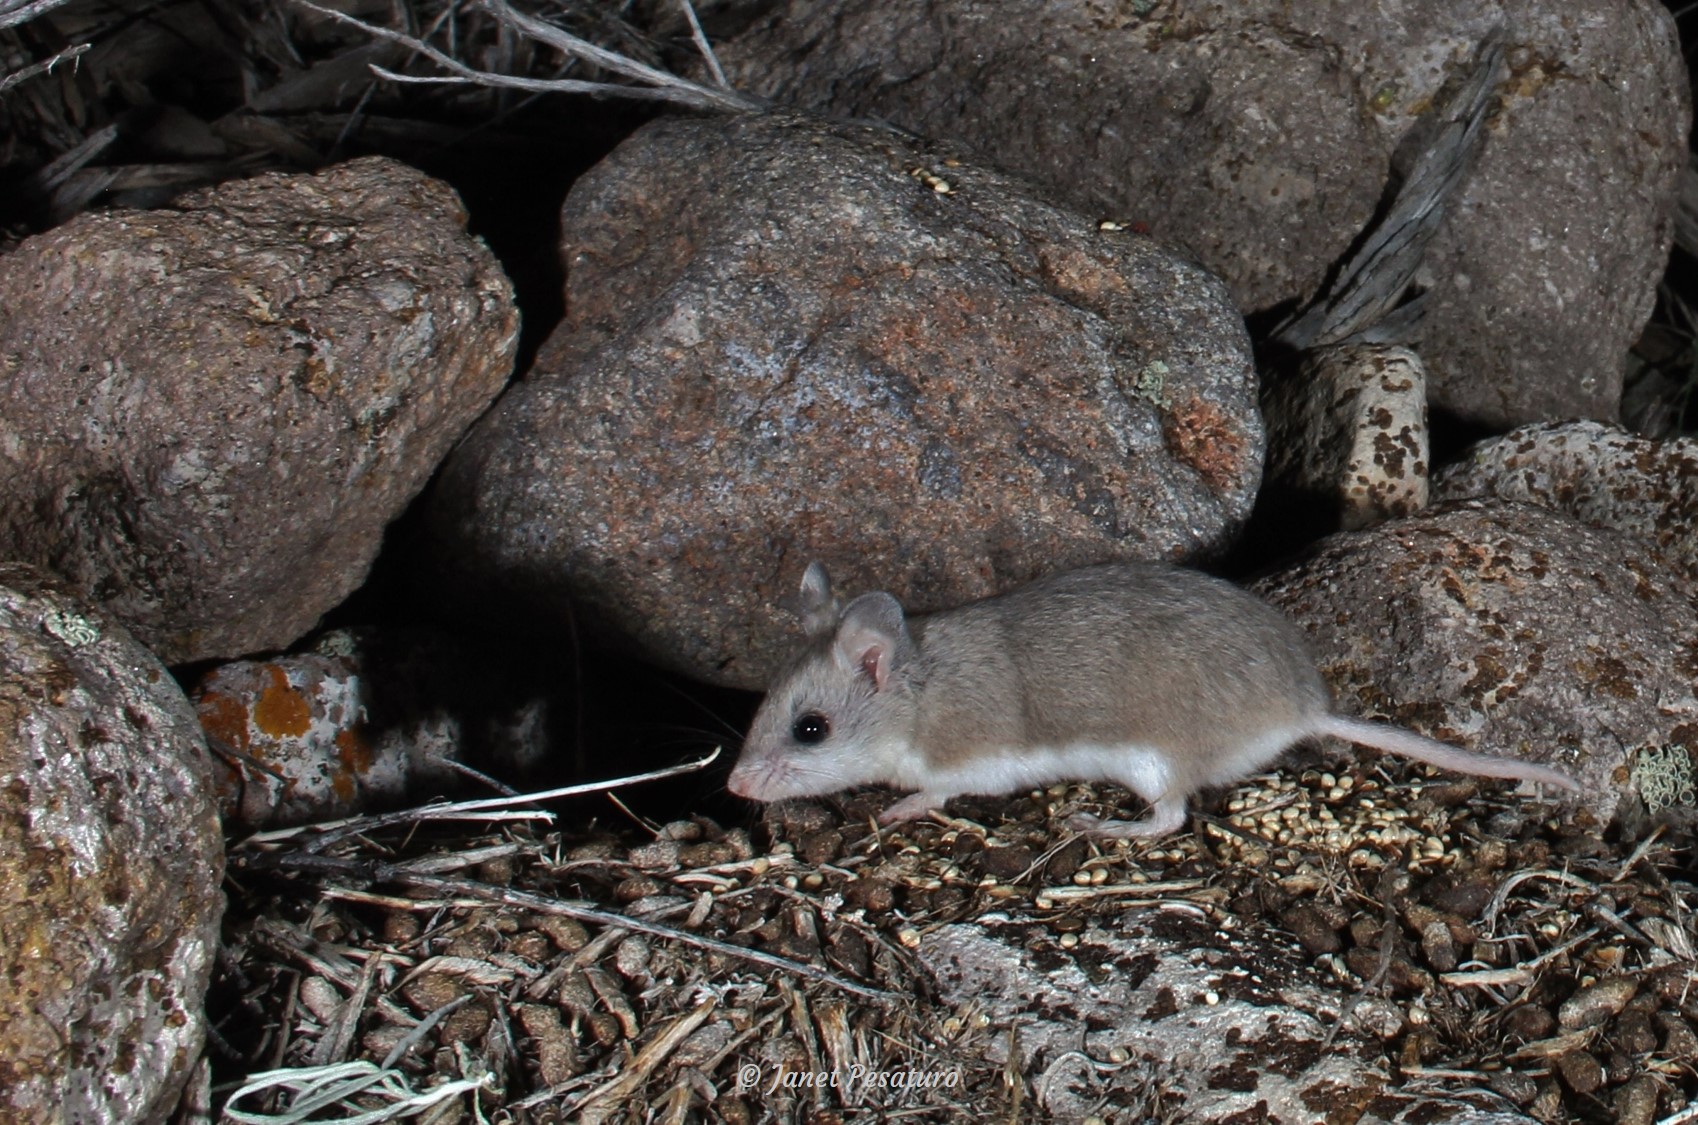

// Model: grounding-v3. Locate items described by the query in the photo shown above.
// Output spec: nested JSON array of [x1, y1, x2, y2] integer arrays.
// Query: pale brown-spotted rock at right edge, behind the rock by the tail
[[1433, 423, 1698, 582]]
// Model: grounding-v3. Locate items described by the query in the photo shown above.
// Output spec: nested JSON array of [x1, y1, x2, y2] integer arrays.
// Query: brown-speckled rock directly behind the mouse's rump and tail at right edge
[[1258, 501, 1698, 820]]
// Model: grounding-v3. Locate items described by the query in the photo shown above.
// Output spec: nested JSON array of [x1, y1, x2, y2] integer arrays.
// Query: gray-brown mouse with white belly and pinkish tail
[[728, 562, 1579, 837]]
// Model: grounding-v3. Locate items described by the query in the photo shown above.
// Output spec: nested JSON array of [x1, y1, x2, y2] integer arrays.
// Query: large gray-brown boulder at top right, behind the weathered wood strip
[[720, 0, 1690, 426]]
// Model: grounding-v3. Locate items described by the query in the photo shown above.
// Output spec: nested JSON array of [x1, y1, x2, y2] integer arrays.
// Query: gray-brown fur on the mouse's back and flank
[[908, 563, 1330, 767]]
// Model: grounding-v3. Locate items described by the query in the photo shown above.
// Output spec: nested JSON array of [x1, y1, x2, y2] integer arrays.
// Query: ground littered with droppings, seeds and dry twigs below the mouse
[[214, 758, 1698, 1122]]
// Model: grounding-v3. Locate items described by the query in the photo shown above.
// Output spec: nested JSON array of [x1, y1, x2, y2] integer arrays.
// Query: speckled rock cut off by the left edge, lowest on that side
[[0, 563, 224, 1125]]
